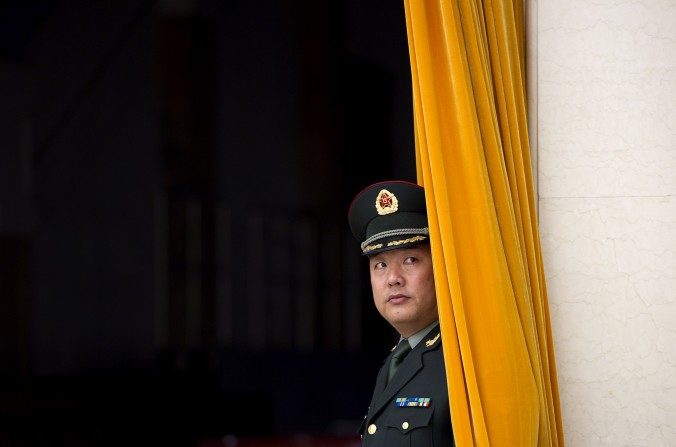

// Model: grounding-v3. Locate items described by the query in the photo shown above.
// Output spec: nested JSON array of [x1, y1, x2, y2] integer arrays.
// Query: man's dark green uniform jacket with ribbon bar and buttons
[[360, 326, 454, 447]]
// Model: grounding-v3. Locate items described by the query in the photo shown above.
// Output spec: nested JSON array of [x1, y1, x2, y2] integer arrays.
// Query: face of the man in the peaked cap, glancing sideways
[[369, 244, 438, 337]]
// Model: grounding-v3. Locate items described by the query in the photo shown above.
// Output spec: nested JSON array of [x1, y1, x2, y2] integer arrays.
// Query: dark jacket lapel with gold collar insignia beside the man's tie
[[369, 326, 440, 415]]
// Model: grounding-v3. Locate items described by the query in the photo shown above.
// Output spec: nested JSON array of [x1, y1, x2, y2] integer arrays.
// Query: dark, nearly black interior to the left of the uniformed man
[[0, 0, 415, 446]]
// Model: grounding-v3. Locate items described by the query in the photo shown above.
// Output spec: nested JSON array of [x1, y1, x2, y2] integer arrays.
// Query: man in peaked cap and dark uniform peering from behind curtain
[[348, 181, 454, 447]]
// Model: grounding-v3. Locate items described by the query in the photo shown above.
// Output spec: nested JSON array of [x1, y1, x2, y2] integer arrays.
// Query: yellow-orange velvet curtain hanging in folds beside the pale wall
[[404, 0, 563, 447]]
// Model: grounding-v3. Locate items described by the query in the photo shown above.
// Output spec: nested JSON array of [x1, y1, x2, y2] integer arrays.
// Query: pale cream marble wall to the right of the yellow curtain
[[528, 0, 676, 447]]
